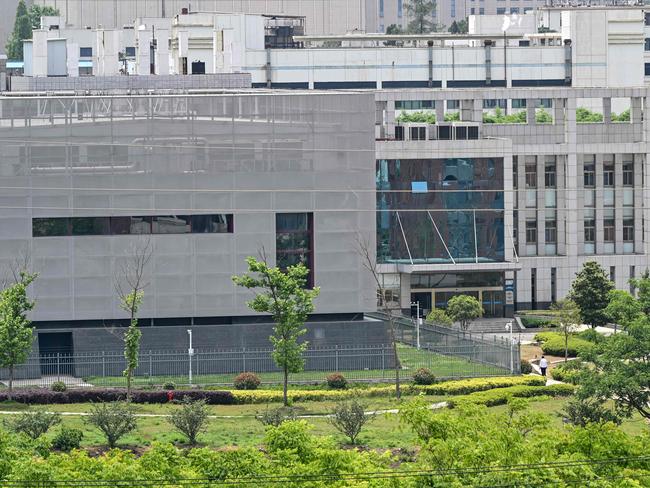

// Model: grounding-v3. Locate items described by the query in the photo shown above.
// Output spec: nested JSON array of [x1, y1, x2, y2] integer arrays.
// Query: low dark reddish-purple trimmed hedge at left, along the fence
[[0, 388, 235, 405]]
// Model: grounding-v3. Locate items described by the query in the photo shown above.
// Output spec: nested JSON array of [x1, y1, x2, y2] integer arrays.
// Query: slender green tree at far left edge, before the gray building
[[0, 271, 37, 392]]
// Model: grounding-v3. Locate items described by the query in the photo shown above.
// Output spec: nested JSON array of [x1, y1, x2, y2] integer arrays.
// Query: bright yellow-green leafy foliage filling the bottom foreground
[[0, 397, 650, 488]]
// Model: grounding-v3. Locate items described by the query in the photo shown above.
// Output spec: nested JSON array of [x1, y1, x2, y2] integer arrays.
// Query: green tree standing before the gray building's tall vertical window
[[232, 257, 320, 406]]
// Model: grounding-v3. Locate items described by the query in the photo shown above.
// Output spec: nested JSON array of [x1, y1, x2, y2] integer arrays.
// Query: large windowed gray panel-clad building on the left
[[0, 86, 386, 351]]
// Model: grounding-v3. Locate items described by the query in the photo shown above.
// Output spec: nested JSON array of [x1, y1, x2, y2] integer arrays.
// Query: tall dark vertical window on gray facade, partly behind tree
[[275, 213, 314, 288]]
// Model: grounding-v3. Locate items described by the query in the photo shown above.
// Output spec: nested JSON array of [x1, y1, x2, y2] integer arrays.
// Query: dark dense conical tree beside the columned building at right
[[569, 261, 614, 327]]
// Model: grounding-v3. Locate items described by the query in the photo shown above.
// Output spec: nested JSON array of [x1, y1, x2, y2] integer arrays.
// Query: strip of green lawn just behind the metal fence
[[84, 345, 507, 387]]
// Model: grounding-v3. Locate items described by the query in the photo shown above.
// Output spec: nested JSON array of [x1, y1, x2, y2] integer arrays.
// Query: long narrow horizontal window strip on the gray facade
[[32, 214, 233, 237]]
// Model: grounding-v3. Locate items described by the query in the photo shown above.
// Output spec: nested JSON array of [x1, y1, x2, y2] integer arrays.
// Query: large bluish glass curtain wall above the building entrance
[[376, 158, 504, 264]]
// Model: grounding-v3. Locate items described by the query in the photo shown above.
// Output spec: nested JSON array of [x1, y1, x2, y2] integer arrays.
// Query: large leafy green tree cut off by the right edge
[[577, 316, 650, 419]]
